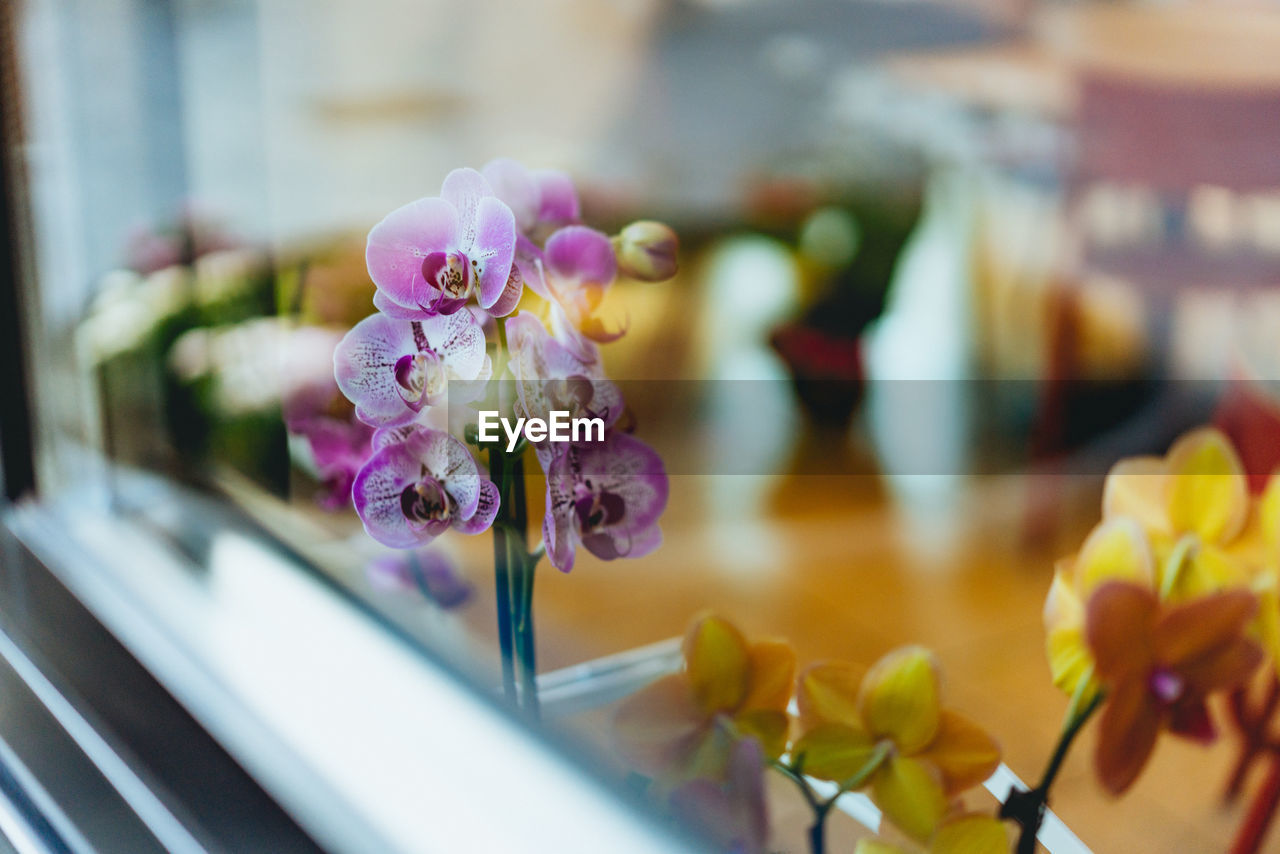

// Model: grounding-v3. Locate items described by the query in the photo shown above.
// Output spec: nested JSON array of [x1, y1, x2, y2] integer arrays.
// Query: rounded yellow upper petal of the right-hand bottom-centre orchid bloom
[[858, 647, 941, 755]]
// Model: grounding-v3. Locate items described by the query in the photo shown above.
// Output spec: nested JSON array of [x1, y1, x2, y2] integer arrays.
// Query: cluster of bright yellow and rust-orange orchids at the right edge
[[1044, 429, 1280, 794]]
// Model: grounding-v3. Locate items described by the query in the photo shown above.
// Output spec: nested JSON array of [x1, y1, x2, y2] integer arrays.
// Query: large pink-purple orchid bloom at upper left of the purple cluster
[[365, 169, 524, 320]]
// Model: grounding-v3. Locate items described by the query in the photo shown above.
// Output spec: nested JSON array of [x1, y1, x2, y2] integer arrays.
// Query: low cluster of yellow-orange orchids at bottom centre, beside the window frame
[[614, 616, 1009, 853]]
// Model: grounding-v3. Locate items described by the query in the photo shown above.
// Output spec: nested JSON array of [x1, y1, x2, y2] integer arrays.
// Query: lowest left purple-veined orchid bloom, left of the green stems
[[351, 428, 499, 548]]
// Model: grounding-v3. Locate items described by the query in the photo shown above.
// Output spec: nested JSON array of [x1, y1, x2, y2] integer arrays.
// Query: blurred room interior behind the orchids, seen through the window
[[15, 0, 1280, 851]]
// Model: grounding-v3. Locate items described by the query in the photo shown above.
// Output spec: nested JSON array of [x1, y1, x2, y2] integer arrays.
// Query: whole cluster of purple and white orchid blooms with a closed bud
[[333, 159, 676, 571]]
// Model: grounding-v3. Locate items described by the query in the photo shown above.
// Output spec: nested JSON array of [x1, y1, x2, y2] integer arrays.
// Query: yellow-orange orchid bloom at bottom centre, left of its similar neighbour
[[613, 616, 795, 780]]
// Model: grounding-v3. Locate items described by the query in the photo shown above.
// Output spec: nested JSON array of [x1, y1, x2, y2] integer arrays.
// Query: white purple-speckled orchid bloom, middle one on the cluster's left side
[[333, 311, 493, 426]]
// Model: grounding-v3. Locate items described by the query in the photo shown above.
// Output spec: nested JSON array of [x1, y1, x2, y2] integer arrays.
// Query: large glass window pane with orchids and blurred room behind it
[[18, 0, 1280, 851]]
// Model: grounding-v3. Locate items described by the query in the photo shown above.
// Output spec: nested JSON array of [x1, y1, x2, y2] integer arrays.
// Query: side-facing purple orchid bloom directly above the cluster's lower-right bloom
[[506, 311, 622, 460]]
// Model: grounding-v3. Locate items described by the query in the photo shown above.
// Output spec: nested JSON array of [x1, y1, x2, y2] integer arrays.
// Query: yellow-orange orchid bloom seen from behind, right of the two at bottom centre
[[791, 647, 1000, 841]]
